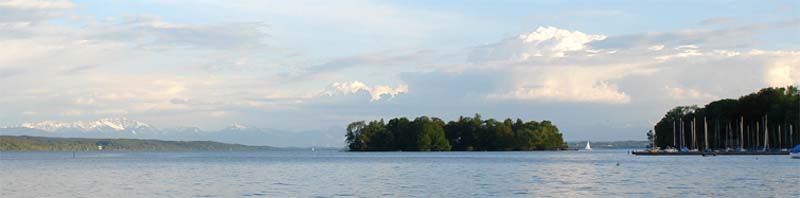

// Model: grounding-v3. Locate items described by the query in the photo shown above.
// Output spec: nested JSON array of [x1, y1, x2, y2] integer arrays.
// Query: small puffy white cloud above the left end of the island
[[325, 81, 408, 101]]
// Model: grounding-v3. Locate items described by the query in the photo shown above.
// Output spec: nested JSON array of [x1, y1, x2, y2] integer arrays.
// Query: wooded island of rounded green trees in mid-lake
[[345, 114, 567, 151]]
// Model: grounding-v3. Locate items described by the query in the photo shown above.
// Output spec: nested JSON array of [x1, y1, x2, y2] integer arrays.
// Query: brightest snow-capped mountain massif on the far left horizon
[[14, 118, 158, 134]]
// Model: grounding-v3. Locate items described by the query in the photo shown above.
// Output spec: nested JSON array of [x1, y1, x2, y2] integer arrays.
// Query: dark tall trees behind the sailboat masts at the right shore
[[648, 86, 800, 150]]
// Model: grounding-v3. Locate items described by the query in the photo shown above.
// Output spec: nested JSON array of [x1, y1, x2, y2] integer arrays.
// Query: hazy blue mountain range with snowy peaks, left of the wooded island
[[0, 118, 344, 147]]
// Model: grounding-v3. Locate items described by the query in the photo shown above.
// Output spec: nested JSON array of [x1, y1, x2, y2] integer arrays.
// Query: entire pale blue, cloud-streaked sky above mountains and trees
[[0, 0, 800, 141]]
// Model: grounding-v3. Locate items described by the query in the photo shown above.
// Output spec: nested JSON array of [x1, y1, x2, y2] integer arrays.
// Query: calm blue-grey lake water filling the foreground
[[0, 150, 800, 197]]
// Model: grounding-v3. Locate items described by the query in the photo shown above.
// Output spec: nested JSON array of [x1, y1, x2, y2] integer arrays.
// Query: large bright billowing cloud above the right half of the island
[[468, 27, 648, 104]]
